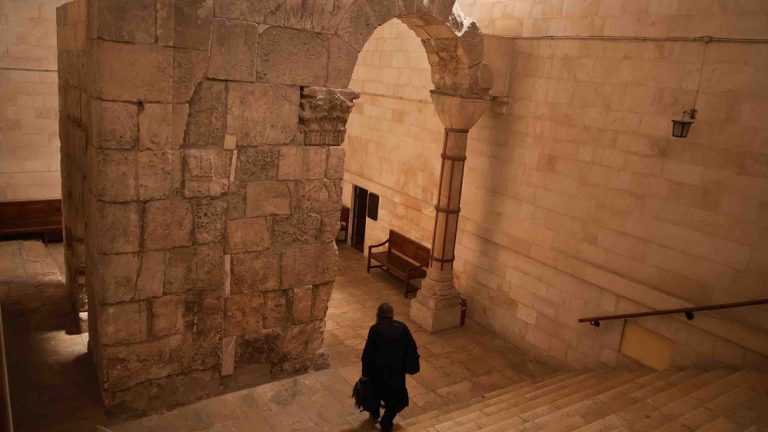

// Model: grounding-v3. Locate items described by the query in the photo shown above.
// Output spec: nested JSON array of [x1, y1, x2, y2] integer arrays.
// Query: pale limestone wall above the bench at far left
[[0, 0, 65, 201]]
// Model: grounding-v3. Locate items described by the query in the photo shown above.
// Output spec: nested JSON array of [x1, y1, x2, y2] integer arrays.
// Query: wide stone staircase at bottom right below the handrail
[[401, 369, 768, 432]]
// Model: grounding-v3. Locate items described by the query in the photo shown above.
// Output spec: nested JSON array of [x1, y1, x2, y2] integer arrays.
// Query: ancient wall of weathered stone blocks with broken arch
[[60, 0, 491, 414]]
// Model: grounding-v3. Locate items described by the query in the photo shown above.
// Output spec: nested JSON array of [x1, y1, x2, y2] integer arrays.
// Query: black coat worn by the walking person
[[362, 319, 418, 411]]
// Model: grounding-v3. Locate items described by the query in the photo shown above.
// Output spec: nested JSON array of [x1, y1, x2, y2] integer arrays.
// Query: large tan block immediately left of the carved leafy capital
[[227, 83, 299, 146]]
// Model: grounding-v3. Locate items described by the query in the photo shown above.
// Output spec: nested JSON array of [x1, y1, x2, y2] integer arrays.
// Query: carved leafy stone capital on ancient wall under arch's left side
[[299, 87, 360, 146]]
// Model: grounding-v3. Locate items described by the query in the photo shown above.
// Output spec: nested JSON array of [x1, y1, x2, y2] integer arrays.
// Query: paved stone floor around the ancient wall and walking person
[[0, 242, 552, 432]]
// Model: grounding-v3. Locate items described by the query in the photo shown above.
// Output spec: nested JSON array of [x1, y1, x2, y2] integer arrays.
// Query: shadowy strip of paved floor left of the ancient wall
[[0, 241, 104, 432]]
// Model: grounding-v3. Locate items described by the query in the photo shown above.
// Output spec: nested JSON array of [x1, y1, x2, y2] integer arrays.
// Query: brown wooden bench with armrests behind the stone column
[[367, 230, 430, 298]]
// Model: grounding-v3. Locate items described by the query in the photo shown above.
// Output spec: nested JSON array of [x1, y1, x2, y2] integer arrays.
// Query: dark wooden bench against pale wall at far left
[[0, 199, 63, 243]]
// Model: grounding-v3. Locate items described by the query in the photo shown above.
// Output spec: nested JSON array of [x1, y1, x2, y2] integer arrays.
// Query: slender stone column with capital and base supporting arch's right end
[[410, 90, 490, 332]]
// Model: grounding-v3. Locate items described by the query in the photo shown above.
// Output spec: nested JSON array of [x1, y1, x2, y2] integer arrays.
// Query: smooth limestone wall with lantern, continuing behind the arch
[[345, 1, 768, 366]]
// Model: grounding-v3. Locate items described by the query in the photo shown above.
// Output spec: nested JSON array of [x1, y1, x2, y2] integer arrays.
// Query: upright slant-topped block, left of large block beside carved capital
[[185, 81, 227, 147]]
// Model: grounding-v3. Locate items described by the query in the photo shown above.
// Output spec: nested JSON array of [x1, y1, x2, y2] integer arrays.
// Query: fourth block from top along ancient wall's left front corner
[[90, 150, 138, 202]]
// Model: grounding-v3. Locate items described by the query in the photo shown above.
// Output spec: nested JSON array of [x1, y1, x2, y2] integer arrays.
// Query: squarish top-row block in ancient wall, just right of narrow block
[[157, 0, 213, 50]]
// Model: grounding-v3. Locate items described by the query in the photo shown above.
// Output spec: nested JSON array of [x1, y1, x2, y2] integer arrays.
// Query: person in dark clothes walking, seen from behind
[[362, 303, 419, 432]]
